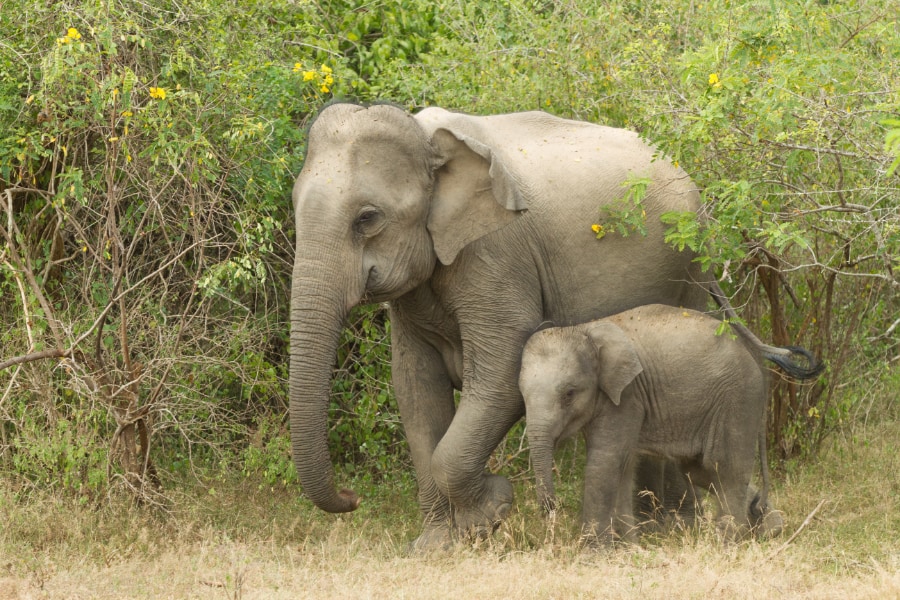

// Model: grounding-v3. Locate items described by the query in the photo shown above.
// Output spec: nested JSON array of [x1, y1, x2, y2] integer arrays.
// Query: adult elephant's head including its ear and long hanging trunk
[[290, 104, 525, 512]]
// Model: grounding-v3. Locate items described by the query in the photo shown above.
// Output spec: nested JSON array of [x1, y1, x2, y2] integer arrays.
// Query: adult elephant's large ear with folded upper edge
[[428, 128, 527, 265]]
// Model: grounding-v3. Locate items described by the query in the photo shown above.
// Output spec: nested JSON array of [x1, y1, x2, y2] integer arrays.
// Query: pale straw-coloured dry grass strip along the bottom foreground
[[0, 529, 900, 598]]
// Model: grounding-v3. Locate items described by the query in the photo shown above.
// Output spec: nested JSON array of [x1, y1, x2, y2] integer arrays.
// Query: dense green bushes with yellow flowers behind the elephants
[[0, 0, 900, 498]]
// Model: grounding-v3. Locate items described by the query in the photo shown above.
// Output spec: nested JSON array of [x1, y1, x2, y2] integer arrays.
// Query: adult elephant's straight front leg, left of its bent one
[[392, 311, 454, 551]]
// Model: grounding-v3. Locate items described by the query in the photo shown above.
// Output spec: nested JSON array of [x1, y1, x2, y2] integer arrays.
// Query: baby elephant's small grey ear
[[585, 320, 644, 406]]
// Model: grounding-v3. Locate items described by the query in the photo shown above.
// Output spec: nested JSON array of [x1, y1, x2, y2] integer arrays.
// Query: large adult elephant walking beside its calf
[[290, 104, 708, 548]]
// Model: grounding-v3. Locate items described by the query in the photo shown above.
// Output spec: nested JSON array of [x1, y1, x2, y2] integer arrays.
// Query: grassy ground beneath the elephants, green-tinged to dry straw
[[0, 421, 900, 600]]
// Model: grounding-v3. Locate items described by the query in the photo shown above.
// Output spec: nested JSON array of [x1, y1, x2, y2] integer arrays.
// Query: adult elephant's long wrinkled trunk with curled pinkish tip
[[290, 251, 359, 513]]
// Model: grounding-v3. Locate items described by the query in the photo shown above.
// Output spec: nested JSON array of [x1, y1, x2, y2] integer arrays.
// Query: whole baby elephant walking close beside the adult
[[519, 304, 780, 545]]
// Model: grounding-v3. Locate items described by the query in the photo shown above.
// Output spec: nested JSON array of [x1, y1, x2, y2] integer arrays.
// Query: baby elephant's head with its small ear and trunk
[[519, 320, 643, 510]]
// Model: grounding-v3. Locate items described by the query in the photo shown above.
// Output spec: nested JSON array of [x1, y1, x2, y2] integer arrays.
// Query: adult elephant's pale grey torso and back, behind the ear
[[416, 108, 707, 325]]
